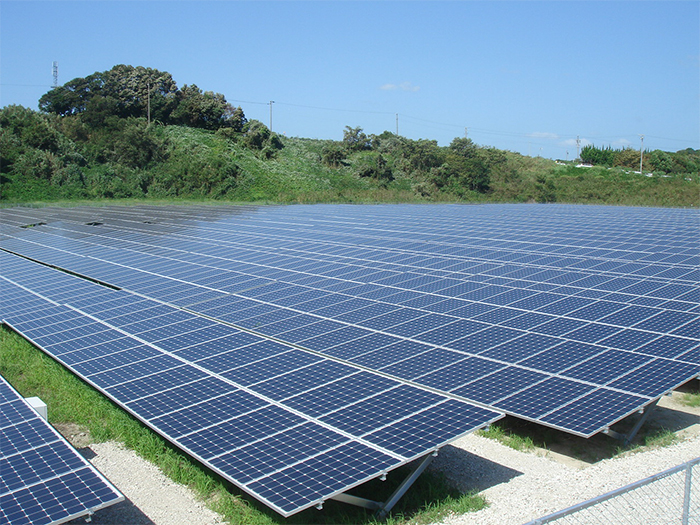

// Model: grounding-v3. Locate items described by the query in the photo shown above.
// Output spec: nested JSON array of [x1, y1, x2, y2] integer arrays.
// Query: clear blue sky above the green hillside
[[0, 0, 700, 159]]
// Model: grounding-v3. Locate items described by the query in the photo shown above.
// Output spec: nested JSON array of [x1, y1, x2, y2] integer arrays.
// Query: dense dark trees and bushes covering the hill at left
[[0, 65, 282, 200]]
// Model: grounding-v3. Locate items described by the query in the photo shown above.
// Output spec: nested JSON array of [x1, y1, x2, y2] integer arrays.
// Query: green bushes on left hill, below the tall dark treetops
[[0, 106, 283, 200]]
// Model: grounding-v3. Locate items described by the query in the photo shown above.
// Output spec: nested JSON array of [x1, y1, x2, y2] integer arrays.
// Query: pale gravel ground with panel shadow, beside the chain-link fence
[[433, 434, 700, 525]]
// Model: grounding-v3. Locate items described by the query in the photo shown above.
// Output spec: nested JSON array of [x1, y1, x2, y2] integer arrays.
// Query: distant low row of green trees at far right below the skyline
[[581, 145, 700, 175]]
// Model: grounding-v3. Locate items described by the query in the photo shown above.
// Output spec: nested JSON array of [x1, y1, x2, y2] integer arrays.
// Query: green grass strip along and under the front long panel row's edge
[[0, 326, 486, 525]]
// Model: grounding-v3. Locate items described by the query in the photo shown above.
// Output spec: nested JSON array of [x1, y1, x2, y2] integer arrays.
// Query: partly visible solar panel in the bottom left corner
[[0, 377, 124, 525]]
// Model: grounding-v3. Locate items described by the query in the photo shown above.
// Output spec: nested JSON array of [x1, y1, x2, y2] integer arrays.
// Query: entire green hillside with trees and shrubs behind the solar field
[[0, 65, 700, 206]]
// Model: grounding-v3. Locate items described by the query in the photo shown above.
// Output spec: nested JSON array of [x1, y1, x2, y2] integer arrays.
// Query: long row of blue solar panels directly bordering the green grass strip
[[0, 254, 502, 515]]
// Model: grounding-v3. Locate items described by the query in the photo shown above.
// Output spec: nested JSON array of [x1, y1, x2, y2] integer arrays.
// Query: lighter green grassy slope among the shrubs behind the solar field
[[0, 126, 700, 207]]
